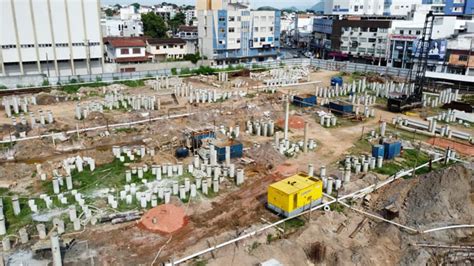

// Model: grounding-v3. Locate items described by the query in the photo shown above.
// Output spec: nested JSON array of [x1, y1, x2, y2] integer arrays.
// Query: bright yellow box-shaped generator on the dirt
[[267, 173, 323, 217]]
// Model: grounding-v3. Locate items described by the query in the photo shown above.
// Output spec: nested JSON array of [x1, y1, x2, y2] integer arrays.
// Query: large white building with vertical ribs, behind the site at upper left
[[0, 0, 103, 76]]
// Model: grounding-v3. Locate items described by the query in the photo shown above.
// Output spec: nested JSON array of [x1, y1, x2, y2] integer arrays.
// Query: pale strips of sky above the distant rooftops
[[101, 0, 318, 9]]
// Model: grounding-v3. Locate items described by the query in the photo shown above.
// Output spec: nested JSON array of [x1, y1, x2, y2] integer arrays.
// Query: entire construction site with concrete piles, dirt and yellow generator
[[0, 61, 474, 265]]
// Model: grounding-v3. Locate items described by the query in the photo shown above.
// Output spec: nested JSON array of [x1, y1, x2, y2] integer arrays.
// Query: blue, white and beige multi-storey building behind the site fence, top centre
[[198, 0, 280, 64]]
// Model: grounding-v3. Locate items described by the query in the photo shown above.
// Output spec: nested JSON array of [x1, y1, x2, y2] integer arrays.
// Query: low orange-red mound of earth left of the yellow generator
[[139, 204, 188, 234]]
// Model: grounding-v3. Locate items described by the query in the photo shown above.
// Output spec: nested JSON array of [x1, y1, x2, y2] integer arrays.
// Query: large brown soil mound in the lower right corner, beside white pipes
[[373, 164, 474, 265]]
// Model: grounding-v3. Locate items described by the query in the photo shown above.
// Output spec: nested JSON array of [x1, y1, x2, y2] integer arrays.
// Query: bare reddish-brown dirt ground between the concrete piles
[[0, 71, 474, 265]]
